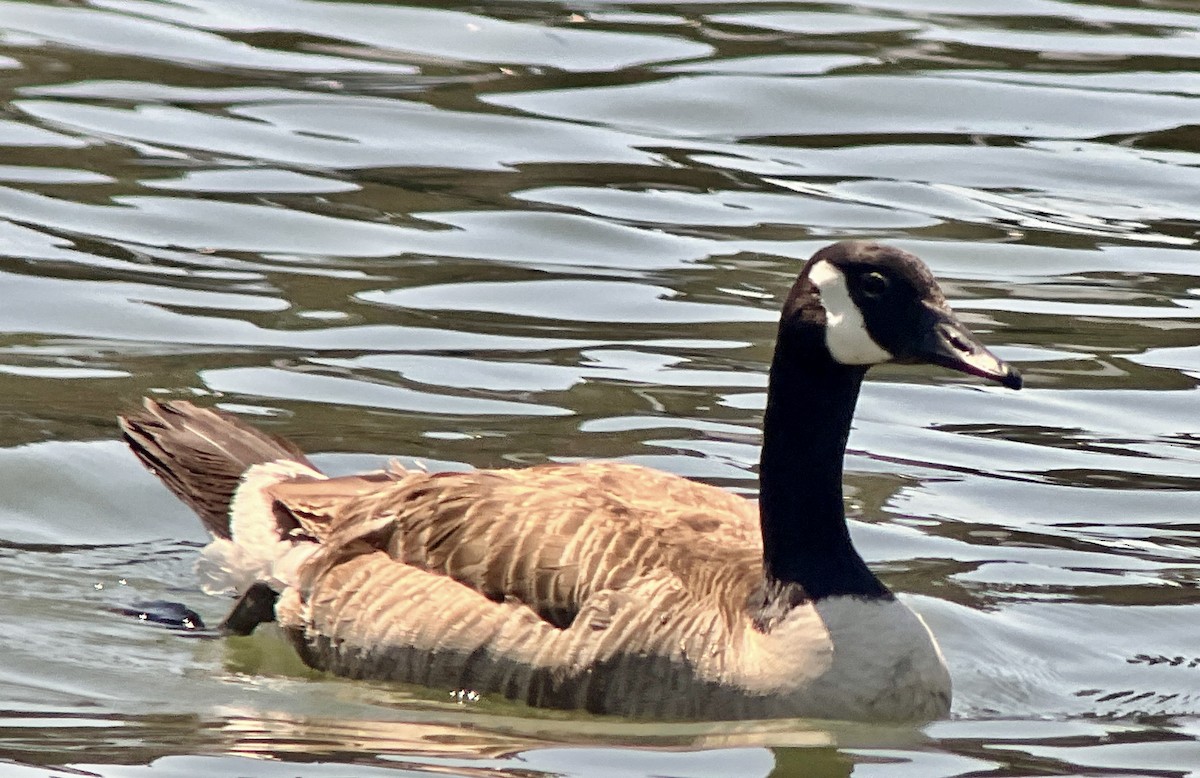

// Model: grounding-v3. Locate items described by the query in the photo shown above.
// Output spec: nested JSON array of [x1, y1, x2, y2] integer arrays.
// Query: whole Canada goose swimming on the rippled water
[[120, 243, 1021, 720]]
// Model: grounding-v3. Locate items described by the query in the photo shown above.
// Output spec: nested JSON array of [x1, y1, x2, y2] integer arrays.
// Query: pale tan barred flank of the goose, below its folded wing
[[276, 547, 749, 718]]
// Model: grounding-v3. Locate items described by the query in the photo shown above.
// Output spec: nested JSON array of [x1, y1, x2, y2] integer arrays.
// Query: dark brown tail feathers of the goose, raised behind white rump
[[119, 397, 316, 539]]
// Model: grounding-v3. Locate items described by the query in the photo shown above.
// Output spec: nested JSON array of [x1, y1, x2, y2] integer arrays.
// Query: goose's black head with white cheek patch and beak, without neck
[[781, 241, 1021, 389]]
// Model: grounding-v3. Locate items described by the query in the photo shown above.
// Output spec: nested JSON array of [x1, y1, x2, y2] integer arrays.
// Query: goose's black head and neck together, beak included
[[758, 241, 1021, 597]]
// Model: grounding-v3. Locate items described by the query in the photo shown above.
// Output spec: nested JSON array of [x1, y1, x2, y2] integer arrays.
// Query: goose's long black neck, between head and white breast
[[758, 321, 890, 600]]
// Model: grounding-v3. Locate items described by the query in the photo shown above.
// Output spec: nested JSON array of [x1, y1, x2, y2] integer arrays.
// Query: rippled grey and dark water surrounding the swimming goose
[[0, 0, 1200, 778]]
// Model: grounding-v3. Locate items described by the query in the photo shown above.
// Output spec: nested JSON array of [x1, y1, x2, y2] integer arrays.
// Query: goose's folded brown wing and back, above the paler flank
[[271, 462, 761, 628]]
